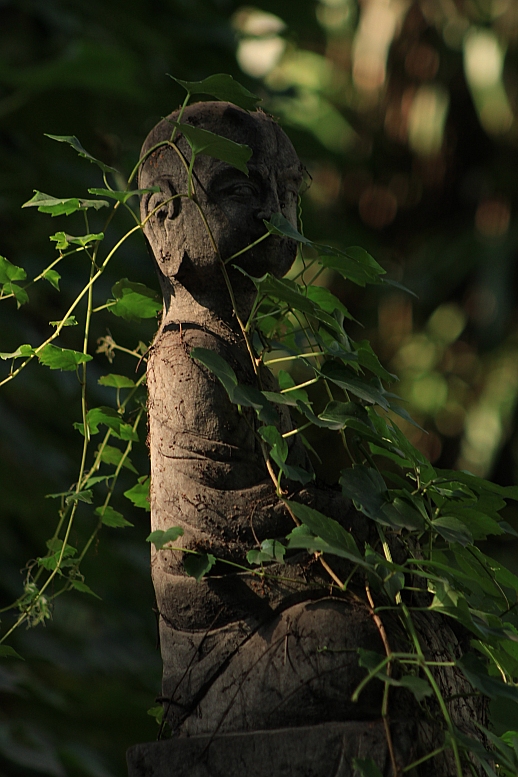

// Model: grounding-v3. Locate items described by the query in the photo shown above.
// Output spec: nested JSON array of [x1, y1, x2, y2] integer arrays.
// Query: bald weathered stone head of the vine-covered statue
[[139, 102, 302, 322]]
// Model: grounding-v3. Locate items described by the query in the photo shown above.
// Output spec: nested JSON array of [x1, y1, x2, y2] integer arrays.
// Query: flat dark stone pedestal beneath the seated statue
[[127, 720, 416, 777]]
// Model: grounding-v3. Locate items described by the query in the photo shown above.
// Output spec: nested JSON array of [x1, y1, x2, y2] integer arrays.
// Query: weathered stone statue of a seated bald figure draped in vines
[[129, 102, 488, 777]]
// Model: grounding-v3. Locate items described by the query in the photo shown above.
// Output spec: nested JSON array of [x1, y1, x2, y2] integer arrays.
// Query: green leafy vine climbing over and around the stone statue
[[0, 75, 518, 777]]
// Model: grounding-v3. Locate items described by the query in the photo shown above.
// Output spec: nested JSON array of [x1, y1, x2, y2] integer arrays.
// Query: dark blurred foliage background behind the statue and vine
[[0, 0, 518, 777]]
